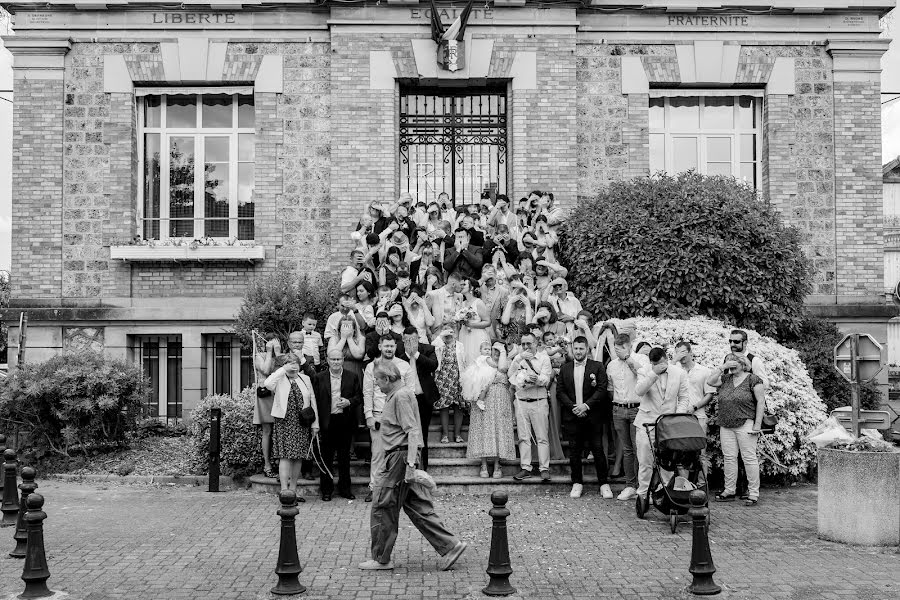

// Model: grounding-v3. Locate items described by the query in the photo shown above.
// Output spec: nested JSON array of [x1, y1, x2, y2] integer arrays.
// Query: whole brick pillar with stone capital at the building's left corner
[[4, 36, 72, 299]]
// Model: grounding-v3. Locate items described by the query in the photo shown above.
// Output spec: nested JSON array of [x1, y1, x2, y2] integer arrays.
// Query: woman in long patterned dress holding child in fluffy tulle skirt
[[463, 342, 516, 479]]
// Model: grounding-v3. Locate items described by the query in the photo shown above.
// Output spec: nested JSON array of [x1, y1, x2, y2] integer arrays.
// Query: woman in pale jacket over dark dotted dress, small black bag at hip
[[265, 353, 319, 494]]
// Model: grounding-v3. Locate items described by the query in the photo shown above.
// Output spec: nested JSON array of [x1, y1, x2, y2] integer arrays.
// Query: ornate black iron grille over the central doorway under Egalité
[[400, 86, 507, 205]]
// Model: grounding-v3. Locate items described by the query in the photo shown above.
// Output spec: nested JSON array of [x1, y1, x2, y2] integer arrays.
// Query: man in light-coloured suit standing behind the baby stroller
[[634, 347, 691, 496]]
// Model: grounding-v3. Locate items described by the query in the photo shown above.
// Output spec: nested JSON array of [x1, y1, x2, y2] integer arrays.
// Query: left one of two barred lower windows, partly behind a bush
[[130, 335, 182, 421]]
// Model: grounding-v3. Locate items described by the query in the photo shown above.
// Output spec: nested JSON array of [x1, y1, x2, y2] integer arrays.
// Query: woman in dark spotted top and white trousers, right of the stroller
[[706, 354, 766, 506]]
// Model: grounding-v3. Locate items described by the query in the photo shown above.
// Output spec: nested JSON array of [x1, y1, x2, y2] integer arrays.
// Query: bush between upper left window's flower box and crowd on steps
[[234, 271, 339, 348]]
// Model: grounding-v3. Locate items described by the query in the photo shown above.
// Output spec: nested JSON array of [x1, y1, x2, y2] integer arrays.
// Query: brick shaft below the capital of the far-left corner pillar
[[12, 78, 68, 299]]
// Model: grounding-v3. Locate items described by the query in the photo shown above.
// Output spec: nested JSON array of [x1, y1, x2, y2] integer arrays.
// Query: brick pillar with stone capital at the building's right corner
[[827, 38, 890, 304]]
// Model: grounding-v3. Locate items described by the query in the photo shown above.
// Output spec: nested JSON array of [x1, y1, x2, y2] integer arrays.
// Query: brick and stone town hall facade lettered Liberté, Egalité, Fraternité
[[4, 0, 895, 417]]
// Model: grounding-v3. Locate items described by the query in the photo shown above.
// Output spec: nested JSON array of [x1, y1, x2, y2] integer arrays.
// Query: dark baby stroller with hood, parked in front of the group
[[635, 413, 709, 533]]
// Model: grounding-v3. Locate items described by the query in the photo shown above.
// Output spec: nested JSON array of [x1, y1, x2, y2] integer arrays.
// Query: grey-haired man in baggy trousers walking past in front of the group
[[359, 359, 466, 571]]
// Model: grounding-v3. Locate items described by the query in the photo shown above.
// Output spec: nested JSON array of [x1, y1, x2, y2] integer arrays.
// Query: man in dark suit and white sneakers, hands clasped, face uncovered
[[556, 336, 613, 500]]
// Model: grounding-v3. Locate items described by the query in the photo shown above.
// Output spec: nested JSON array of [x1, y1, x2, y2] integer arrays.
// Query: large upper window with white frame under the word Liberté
[[140, 94, 256, 240]]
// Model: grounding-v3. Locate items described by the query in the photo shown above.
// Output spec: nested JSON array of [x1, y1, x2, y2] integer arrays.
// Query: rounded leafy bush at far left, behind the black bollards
[[0, 352, 148, 456]]
